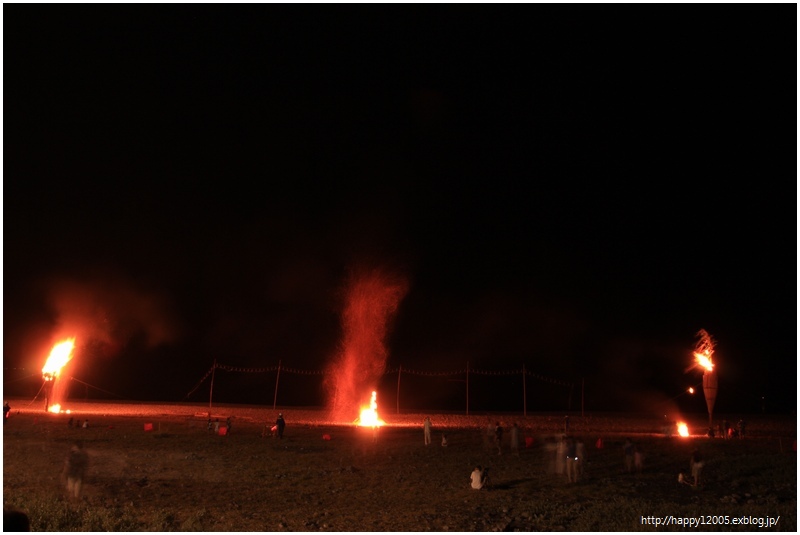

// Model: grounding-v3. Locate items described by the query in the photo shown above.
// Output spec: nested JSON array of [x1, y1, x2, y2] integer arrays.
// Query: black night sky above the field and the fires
[[3, 5, 797, 414]]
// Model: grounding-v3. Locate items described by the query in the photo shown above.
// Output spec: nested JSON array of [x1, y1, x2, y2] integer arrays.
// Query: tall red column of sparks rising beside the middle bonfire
[[325, 270, 408, 422]]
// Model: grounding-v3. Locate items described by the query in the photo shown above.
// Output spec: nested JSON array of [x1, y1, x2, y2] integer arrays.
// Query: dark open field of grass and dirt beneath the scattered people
[[3, 400, 797, 532]]
